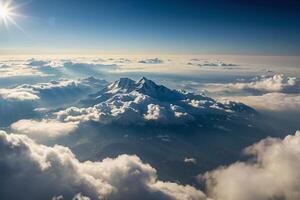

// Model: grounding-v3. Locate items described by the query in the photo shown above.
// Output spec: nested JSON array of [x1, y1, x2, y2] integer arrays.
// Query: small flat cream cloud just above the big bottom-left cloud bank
[[11, 119, 77, 139]]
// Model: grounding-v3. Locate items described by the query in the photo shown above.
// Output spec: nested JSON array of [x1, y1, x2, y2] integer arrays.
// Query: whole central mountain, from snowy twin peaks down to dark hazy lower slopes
[[54, 78, 265, 186]]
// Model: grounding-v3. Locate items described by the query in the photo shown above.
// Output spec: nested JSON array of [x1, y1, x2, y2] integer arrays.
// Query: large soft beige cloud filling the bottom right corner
[[200, 131, 300, 200]]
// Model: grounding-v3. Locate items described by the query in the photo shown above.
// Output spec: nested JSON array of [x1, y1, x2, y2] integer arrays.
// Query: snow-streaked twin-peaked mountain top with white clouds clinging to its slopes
[[55, 77, 256, 125]]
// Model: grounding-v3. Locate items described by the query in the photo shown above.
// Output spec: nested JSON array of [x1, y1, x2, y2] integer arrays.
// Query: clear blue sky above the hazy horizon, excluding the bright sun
[[0, 0, 300, 55]]
